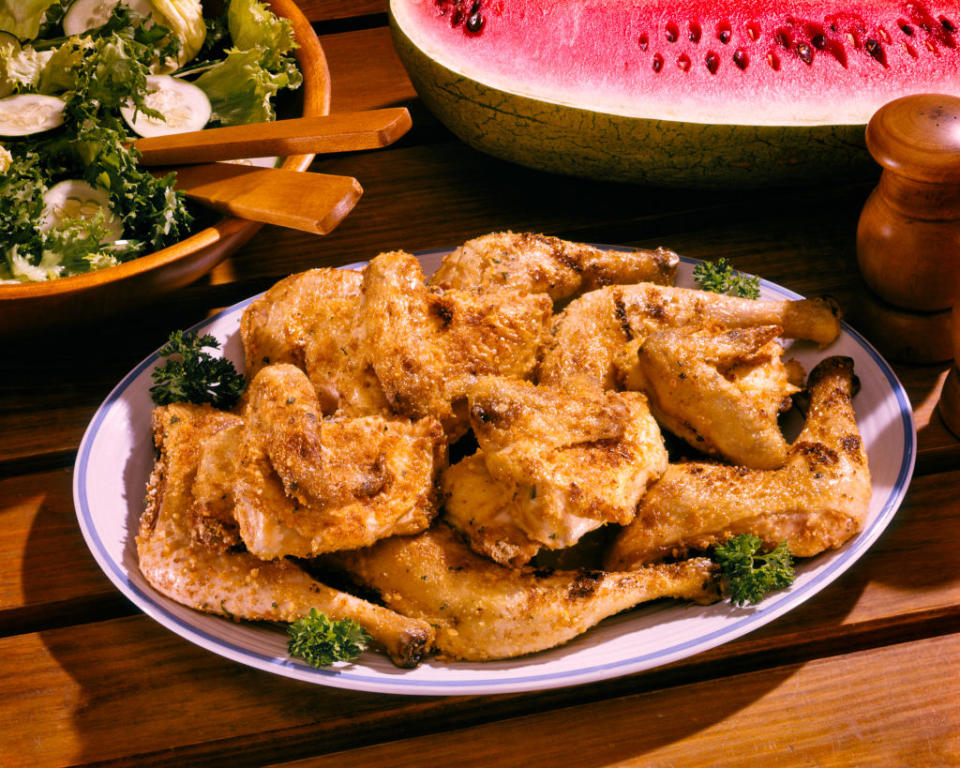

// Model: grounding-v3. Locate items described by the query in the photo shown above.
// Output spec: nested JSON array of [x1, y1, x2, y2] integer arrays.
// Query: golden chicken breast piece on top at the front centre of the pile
[[464, 376, 667, 549]]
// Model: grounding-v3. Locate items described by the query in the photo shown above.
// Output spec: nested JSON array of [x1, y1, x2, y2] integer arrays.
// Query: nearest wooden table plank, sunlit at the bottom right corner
[[266, 635, 960, 768]]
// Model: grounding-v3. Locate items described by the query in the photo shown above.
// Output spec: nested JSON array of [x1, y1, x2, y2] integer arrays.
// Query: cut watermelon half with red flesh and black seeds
[[390, 0, 960, 187]]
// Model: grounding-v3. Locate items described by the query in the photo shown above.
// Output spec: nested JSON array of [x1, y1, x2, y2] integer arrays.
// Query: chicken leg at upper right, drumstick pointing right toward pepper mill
[[538, 283, 840, 389]]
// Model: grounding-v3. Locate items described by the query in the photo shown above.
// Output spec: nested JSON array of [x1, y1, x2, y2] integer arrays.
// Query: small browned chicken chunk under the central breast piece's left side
[[441, 451, 544, 568]]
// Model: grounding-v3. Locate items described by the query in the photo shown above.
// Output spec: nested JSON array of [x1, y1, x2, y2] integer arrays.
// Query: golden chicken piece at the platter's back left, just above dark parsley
[[240, 268, 362, 378]]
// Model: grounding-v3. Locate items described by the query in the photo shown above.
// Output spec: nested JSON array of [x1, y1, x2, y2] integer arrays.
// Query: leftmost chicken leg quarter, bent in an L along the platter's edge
[[136, 404, 434, 667]]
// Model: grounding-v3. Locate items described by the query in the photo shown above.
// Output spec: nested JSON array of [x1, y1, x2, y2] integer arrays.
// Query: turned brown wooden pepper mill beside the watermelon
[[857, 94, 960, 434]]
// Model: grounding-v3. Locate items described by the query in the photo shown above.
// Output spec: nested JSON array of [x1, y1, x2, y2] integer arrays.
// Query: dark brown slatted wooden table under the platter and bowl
[[0, 0, 960, 768]]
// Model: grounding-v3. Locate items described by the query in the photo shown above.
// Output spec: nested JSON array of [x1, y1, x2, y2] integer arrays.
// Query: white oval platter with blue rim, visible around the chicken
[[74, 252, 916, 695]]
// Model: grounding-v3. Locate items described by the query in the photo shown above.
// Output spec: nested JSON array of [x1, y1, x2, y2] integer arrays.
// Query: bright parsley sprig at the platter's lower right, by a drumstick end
[[713, 533, 795, 605]]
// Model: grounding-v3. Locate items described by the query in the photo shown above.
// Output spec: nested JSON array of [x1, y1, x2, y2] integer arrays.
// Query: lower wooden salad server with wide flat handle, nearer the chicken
[[176, 163, 363, 235]]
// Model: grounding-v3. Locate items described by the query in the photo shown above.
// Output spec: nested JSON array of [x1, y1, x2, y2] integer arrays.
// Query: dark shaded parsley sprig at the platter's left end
[[150, 331, 246, 408]]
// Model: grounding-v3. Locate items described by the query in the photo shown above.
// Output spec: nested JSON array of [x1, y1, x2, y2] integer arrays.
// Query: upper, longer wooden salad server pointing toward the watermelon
[[133, 107, 411, 166]]
